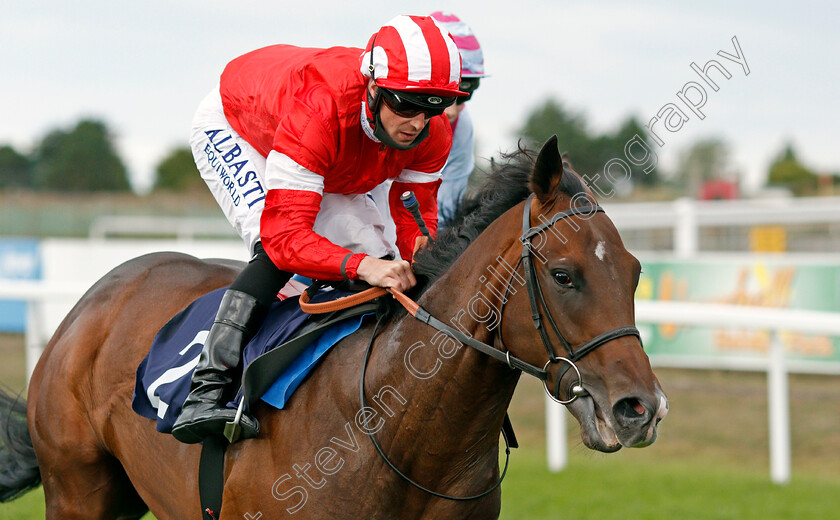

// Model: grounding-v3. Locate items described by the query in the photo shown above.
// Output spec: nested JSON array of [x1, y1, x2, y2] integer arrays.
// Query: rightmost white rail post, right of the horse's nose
[[767, 331, 790, 484]]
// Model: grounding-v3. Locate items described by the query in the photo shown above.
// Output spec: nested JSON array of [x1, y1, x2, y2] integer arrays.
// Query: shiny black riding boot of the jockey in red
[[172, 289, 267, 444]]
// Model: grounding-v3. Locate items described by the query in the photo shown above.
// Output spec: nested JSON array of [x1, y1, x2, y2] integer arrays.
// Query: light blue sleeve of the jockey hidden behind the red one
[[438, 107, 475, 225]]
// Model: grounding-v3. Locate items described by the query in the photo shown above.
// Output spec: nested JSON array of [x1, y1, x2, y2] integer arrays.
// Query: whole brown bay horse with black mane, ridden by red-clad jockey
[[0, 137, 667, 520]]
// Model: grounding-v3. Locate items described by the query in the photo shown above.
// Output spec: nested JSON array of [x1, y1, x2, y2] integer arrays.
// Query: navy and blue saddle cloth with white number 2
[[131, 287, 364, 433]]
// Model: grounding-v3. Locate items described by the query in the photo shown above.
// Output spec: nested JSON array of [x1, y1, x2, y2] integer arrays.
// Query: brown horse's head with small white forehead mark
[[502, 137, 668, 452]]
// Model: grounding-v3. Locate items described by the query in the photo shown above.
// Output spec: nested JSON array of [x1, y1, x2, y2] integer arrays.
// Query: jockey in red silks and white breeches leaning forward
[[172, 16, 468, 443]]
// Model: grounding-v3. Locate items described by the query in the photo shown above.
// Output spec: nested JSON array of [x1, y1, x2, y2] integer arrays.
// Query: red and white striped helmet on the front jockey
[[361, 15, 467, 97]]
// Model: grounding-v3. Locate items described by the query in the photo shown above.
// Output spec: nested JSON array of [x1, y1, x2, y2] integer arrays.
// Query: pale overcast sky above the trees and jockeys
[[0, 0, 840, 194]]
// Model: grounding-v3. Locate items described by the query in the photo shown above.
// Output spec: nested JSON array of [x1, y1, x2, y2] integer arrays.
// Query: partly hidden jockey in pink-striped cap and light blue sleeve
[[429, 11, 485, 223]]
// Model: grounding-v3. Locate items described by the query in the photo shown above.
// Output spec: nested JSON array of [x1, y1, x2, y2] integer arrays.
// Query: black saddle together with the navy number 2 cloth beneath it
[[132, 285, 377, 433]]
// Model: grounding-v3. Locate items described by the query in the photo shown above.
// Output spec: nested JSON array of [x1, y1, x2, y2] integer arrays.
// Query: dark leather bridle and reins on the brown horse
[[359, 194, 641, 501]]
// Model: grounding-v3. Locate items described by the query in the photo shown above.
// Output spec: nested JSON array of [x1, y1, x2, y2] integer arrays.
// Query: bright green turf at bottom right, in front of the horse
[[501, 450, 840, 520]]
